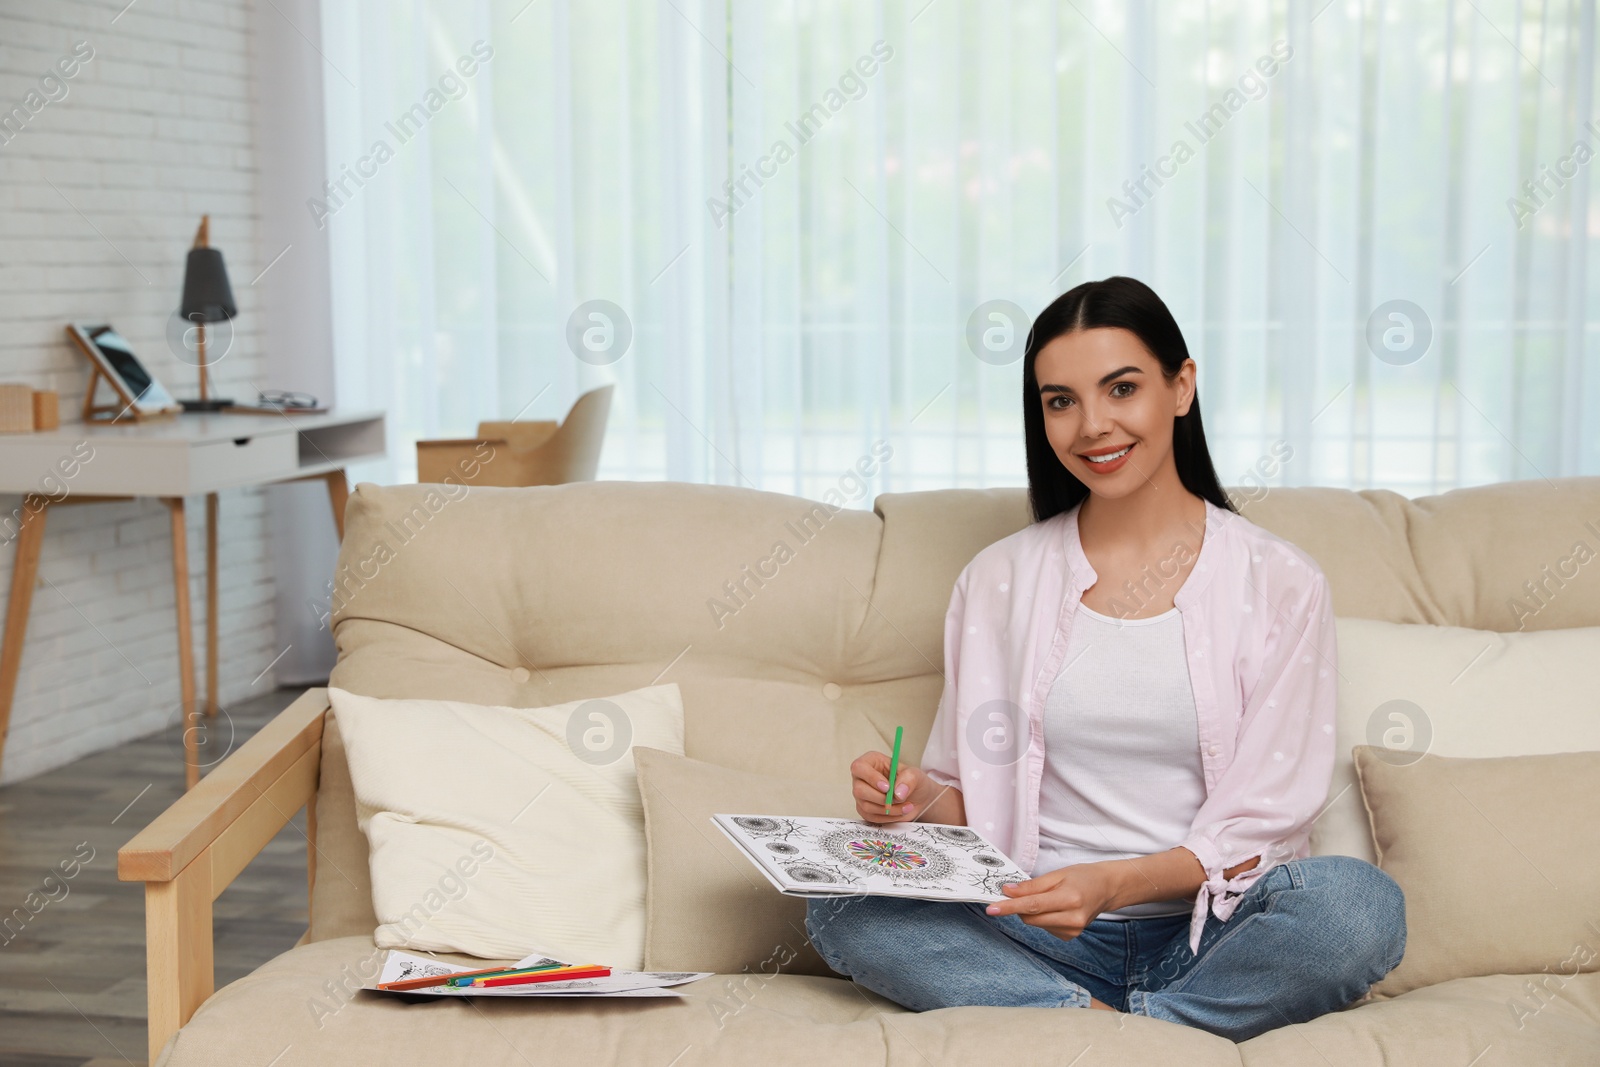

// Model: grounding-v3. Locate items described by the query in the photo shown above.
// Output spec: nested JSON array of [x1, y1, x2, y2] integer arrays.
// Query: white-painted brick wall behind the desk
[[0, 0, 282, 782]]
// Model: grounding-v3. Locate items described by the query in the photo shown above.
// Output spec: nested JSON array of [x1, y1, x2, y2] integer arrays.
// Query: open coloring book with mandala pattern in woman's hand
[[710, 814, 1029, 902]]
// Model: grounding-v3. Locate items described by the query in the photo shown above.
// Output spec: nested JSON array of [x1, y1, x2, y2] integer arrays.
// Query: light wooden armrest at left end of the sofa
[[117, 689, 328, 1064]]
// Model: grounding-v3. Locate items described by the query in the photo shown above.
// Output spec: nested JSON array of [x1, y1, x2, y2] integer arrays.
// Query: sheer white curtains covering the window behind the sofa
[[318, 0, 1600, 507]]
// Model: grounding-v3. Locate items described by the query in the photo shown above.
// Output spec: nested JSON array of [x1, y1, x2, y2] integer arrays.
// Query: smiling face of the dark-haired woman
[[1034, 326, 1195, 496]]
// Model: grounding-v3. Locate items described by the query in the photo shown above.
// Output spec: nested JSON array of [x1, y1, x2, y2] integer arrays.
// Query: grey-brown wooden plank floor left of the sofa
[[0, 688, 307, 1067]]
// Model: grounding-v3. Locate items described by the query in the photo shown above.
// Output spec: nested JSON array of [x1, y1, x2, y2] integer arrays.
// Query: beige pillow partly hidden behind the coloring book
[[634, 749, 856, 976]]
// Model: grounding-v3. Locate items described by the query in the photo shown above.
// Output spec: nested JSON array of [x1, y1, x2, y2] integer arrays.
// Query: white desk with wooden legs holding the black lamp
[[0, 411, 386, 785]]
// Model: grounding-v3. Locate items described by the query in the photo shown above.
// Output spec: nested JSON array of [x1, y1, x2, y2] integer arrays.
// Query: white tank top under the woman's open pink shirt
[[1032, 601, 1205, 920]]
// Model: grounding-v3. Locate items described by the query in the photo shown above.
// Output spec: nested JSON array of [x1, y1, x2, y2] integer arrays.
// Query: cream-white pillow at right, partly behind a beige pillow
[[1310, 619, 1600, 864]]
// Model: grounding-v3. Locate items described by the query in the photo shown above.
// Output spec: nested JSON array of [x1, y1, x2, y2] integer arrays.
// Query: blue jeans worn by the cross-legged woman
[[805, 856, 1405, 1041]]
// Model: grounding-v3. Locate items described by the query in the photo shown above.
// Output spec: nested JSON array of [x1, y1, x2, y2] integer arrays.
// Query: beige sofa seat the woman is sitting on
[[155, 937, 1600, 1067]]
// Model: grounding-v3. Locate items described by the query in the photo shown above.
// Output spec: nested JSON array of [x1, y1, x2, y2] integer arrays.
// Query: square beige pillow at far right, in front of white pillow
[[1355, 745, 1600, 998]]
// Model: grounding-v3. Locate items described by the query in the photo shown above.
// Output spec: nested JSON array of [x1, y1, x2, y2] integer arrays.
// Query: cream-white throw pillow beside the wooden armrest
[[325, 683, 683, 969]]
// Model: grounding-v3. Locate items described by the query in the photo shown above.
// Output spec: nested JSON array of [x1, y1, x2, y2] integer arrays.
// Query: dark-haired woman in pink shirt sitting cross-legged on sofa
[[806, 277, 1405, 1041]]
